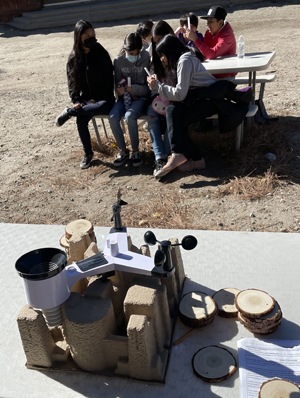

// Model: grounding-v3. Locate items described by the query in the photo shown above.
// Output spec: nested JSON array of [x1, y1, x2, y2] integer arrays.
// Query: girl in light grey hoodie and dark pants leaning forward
[[147, 35, 216, 178]]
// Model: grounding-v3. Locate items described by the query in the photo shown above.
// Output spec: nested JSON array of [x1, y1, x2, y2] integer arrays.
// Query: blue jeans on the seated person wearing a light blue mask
[[108, 98, 145, 151]]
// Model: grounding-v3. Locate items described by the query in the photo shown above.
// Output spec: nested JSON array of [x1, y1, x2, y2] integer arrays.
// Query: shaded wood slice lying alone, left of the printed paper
[[192, 346, 237, 383]]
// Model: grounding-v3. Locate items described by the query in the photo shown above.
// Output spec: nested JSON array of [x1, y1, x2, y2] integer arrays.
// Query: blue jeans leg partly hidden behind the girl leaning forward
[[147, 105, 171, 160]]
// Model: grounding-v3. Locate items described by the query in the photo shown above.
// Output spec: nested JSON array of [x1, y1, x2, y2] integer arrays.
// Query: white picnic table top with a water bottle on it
[[203, 51, 275, 75]]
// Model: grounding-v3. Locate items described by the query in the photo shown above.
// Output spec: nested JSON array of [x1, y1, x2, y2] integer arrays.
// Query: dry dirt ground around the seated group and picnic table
[[0, 1, 300, 232]]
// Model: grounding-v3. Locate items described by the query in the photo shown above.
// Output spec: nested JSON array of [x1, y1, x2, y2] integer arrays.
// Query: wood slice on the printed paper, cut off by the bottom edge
[[258, 379, 300, 398]]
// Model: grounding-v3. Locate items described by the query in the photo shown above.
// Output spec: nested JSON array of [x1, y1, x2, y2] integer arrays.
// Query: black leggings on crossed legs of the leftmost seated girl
[[68, 101, 114, 155]]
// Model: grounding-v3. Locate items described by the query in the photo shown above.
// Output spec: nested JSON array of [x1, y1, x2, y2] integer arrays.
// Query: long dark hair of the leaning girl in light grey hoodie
[[156, 35, 204, 69]]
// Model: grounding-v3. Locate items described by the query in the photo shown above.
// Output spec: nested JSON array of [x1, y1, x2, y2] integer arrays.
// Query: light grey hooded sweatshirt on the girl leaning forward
[[154, 52, 216, 101]]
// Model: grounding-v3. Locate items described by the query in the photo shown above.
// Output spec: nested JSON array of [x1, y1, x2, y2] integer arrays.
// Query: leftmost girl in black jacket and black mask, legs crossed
[[55, 20, 115, 169]]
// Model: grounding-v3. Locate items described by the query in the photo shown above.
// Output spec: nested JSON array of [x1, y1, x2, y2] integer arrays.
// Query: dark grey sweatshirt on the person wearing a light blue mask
[[114, 49, 150, 97]]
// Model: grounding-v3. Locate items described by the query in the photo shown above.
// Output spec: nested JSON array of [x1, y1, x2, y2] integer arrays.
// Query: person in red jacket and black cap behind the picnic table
[[186, 6, 236, 80]]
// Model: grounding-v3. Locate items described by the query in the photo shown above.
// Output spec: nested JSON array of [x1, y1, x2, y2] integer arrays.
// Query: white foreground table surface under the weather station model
[[0, 223, 300, 398]]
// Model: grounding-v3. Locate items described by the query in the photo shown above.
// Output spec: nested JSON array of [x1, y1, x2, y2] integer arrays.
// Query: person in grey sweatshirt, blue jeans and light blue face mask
[[109, 32, 150, 167]]
